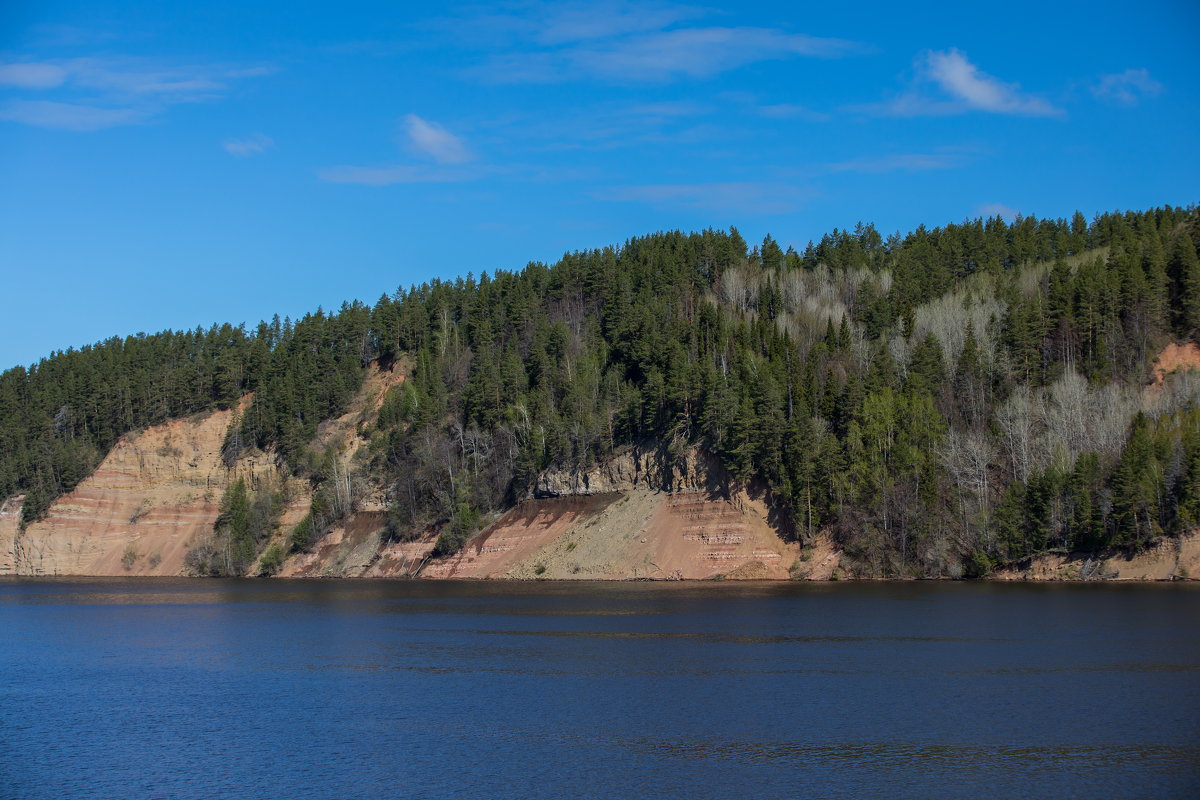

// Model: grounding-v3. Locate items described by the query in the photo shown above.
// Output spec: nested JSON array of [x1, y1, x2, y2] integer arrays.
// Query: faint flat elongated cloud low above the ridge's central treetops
[[594, 181, 811, 215]]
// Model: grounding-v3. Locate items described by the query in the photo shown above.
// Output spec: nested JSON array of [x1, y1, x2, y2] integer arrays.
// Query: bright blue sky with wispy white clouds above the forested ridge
[[0, 0, 1200, 368]]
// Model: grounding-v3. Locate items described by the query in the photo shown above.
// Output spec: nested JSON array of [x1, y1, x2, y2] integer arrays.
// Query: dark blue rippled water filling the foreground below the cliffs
[[0, 579, 1200, 800]]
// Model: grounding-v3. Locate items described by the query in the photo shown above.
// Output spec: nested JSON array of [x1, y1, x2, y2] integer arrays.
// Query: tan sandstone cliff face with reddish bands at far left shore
[[0, 409, 304, 576]]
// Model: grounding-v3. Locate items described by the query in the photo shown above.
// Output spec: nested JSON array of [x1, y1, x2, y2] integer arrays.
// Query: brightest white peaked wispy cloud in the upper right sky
[[859, 48, 1063, 116]]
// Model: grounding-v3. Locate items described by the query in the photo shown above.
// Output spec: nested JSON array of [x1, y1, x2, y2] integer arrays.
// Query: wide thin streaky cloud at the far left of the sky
[[0, 58, 270, 131]]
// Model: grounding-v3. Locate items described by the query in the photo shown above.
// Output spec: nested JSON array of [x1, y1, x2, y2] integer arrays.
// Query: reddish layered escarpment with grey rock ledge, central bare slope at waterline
[[281, 446, 800, 579]]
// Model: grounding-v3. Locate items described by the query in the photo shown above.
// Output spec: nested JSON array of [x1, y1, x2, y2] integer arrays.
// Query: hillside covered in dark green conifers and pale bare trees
[[0, 207, 1200, 576]]
